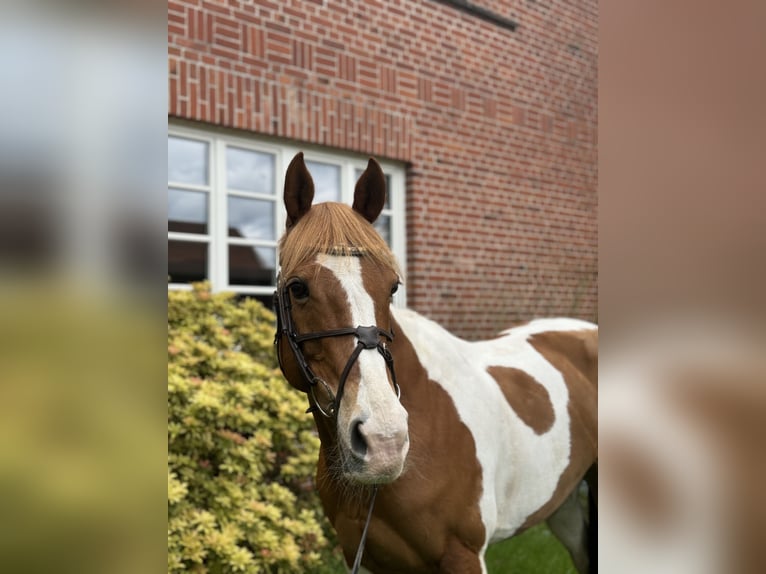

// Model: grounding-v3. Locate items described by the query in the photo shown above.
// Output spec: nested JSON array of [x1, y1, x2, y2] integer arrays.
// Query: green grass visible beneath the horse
[[316, 524, 576, 574]]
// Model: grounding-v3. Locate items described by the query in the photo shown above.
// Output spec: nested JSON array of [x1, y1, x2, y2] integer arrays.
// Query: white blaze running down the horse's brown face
[[317, 254, 407, 476]]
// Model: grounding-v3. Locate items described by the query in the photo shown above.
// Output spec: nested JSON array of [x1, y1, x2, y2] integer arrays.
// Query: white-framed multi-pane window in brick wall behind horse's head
[[168, 126, 406, 306]]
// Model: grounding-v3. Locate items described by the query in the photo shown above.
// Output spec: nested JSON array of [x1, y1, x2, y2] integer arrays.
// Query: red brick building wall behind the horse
[[168, 0, 598, 338]]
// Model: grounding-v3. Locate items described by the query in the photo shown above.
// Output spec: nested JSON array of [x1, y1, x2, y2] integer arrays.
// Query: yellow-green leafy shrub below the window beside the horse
[[168, 284, 337, 573]]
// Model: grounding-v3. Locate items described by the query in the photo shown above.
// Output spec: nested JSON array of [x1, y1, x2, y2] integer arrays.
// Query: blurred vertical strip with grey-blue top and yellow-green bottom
[[0, 2, 167, 572]]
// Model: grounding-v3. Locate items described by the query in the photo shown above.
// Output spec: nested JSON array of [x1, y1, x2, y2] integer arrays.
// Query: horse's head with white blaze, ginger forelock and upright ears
[[277, 153, 409, 483]]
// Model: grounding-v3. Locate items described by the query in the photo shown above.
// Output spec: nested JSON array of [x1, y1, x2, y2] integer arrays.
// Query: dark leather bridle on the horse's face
[[274, 280, 401, 418]]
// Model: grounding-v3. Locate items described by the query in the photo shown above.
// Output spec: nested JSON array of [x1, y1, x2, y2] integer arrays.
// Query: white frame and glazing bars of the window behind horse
[[168, 124, 407, 307]]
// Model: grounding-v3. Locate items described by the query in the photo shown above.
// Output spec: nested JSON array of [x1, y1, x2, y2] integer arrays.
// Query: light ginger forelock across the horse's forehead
[[279, 202, 401, 277]]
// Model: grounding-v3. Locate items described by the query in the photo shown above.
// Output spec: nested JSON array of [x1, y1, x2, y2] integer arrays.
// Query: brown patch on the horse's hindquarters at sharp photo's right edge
[[521, 329, 598, 530]]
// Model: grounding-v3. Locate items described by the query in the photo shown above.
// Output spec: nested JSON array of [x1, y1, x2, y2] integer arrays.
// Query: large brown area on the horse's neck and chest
[[317, 323, 486, 574]]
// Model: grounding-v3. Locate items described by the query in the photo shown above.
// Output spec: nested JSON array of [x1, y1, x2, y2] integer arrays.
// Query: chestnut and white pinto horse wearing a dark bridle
[[274, 152, 598, 574]]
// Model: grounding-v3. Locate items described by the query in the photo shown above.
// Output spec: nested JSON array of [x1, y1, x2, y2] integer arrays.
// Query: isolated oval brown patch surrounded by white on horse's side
[[487, 367, 556, 434]]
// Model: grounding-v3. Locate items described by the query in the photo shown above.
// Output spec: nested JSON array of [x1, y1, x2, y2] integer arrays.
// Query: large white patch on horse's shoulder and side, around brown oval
[[393, 309, 596, 547]]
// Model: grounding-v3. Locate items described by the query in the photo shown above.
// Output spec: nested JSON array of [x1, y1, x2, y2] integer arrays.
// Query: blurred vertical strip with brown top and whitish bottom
[[599, 2, 766, 573]]
